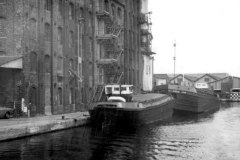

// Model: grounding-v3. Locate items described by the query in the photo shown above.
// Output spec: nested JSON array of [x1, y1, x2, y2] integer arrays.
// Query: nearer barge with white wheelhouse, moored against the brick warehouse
[[89, 85, 173, 126]]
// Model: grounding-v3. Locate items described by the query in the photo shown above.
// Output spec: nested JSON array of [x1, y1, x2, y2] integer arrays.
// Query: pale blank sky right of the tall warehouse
[[148, 0, 240, 77]]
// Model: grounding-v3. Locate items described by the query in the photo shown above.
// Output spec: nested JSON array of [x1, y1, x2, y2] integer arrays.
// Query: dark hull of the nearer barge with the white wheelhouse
[[89, 100, 174, 127]]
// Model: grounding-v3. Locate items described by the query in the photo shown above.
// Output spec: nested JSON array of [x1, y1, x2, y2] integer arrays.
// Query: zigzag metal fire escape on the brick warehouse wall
[[91, 6, 124, 102]]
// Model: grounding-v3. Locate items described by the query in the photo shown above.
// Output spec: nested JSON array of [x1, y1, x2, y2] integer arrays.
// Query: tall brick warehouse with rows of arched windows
[[0, 0, 150, 116]]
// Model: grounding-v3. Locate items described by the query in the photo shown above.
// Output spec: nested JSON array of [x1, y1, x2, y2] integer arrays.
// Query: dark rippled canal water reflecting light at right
[[0, 103, 240, 160]]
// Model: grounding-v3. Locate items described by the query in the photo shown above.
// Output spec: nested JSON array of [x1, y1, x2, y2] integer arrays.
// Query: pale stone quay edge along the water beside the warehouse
[[0, 112, 89, 141]]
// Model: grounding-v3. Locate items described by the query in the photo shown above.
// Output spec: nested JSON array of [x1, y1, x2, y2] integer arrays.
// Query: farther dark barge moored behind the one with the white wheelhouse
[[154, 84, 220, 113]]
